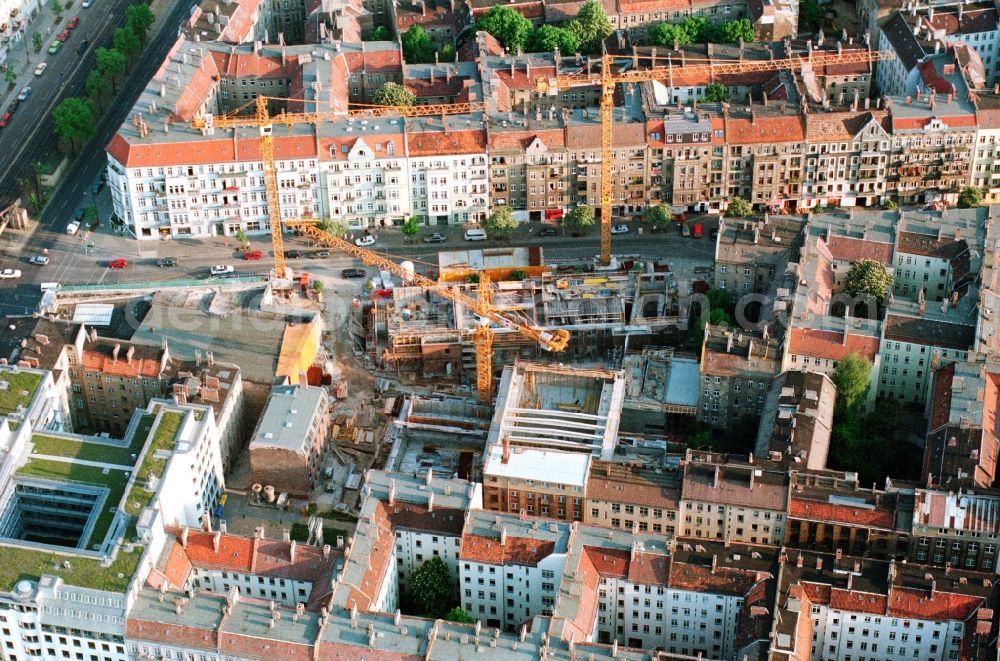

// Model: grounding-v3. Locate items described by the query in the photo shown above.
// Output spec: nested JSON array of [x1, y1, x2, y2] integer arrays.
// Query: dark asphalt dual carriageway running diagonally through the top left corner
[[0, 0, 191, 215]]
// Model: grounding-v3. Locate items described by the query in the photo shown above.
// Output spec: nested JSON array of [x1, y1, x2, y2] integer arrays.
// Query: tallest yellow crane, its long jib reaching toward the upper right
[[537, 50, 895, 266]]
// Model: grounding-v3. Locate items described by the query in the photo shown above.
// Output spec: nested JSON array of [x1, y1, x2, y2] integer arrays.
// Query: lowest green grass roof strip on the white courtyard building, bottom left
[[0, 546, 143, 592]]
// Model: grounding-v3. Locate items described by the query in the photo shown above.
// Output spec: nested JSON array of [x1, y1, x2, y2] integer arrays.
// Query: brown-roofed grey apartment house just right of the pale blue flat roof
[[698, 324, 781, 428]]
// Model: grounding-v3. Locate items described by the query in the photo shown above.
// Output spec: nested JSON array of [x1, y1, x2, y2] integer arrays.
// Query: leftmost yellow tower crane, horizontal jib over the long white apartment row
[[191, 96, 484, 278]]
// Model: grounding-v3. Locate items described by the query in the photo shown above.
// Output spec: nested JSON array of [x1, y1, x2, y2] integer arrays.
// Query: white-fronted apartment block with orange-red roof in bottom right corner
[[770, 551, 992, 661]]
